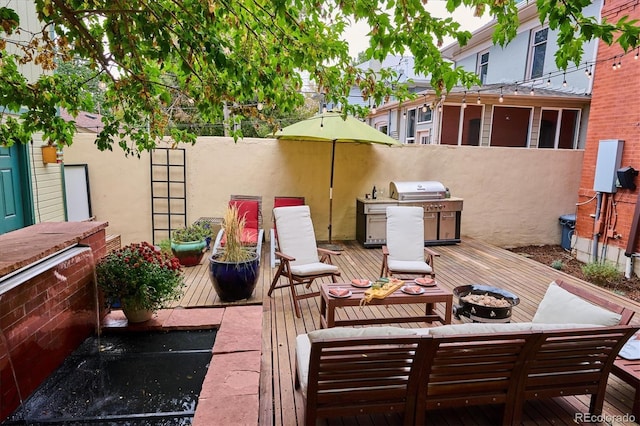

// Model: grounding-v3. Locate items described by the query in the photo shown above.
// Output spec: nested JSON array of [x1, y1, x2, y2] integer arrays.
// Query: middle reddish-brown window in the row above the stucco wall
[[491, 106, 531, 148]]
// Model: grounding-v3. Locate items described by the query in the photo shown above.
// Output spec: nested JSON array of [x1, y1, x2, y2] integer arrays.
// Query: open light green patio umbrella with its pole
[[275, 111, 402, 243]]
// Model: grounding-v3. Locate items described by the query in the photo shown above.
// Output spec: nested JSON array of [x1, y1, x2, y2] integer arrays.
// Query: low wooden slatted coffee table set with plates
[[320, 282, 453, 328]]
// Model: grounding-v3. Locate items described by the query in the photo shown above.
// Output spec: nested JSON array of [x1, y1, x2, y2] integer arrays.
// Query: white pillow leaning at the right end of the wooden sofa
[[532, 282, 622, 326]]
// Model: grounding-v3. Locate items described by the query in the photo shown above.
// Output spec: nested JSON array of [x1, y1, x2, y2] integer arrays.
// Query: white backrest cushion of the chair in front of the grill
[[386, 206, 424, 262]]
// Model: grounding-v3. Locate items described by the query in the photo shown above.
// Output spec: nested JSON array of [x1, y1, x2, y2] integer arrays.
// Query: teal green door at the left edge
[[0, 146, 25, 234]]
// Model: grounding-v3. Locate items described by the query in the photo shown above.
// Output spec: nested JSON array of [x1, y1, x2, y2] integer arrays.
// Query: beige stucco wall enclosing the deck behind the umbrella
[[64, 134, 583, 246]]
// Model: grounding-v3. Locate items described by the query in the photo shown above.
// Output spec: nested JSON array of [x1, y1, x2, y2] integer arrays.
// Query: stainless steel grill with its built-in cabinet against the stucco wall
[[356, 181, 463, 247]]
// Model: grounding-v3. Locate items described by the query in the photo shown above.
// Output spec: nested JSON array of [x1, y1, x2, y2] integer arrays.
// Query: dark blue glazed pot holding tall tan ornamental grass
[[209, 206, 260, 302]]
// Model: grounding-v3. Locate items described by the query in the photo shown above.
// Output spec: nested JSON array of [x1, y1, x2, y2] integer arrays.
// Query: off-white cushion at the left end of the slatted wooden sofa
[[296, 327, 416, 395]]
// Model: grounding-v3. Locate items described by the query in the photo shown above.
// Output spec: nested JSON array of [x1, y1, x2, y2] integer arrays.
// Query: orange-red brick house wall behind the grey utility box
[[576, 0, 640, 251]]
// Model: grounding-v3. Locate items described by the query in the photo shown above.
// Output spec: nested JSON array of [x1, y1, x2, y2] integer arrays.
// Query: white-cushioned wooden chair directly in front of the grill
[[380, 206, 438, 278]]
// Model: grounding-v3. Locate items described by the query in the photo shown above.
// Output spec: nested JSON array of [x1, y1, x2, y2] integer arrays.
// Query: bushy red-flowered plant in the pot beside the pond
[[96, 242, 185, 311]]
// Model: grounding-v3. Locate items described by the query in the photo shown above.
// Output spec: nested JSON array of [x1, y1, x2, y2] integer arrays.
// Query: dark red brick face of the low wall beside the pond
[[0, 229, 106, 421]]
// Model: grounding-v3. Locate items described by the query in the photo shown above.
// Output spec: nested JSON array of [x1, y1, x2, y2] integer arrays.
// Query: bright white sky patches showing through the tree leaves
[[345, 0, 491, 58]]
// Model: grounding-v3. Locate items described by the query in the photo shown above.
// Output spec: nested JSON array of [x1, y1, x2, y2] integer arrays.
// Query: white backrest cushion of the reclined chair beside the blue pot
[[273, 206, 320, 265]]
